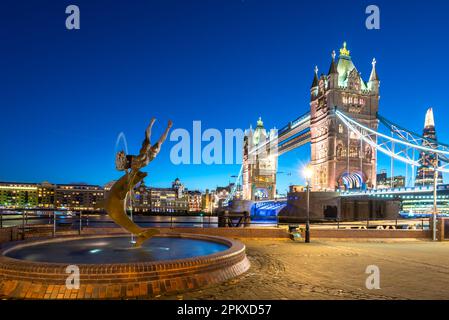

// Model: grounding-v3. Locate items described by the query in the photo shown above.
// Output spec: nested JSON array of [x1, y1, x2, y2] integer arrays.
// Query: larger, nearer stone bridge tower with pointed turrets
[[310, 42, 380, 191]]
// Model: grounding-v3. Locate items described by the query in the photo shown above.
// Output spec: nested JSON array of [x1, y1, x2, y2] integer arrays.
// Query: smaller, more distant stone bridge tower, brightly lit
[[242, 118, 278, 201]]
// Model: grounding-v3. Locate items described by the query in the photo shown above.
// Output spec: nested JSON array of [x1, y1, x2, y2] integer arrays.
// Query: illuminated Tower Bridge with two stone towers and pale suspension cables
[[227, 43, 449, 219]]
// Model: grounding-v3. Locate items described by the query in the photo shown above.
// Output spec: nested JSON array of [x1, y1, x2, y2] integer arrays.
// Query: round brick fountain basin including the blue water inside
[[0, 233, 249, 299]]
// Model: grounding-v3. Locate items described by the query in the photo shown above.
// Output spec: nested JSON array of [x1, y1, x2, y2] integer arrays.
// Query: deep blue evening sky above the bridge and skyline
[[0, 0, 449, 192]]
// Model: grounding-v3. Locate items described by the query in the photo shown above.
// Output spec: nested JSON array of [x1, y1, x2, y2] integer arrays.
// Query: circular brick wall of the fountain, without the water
[[0, 233, 250, 299]]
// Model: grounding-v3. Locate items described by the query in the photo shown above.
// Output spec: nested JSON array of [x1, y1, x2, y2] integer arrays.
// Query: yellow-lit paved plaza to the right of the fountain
[[162, 239, 449, 300]]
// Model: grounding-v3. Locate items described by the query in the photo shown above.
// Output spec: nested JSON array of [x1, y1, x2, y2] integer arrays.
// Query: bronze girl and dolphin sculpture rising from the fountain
[[103, 118, 173, 247]]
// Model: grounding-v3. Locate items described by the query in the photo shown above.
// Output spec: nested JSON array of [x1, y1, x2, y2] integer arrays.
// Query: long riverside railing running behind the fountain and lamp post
[[0, 208, 430, 237]]
